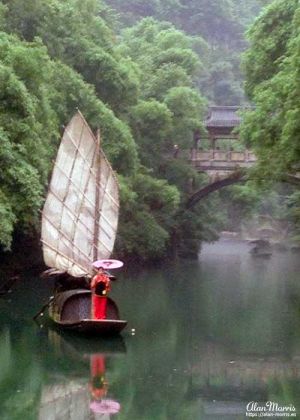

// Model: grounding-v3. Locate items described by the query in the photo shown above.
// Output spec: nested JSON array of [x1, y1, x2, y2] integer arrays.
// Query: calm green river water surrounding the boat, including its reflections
[[0, 241, 300, 420]]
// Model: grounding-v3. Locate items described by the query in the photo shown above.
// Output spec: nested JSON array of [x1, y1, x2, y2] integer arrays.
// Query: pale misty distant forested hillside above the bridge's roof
[[108, 0, 266, 105]]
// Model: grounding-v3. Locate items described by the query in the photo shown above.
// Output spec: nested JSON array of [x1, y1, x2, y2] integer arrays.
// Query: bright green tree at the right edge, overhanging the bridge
[[242, 0, 300, 178]]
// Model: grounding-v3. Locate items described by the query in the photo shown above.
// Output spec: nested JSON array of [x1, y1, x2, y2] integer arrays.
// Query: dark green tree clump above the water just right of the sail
[[116, 174, 180, 261]]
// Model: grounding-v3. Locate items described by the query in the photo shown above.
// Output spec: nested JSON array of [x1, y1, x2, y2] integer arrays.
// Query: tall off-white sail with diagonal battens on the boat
[[42, 112, 119, 277]]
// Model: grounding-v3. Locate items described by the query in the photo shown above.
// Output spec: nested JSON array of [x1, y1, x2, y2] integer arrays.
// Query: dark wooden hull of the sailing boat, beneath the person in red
[[49, 289, 127, 335]]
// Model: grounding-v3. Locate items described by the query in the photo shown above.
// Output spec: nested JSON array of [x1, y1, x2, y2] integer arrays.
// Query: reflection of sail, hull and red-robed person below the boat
[[39, 330, 126, 420]]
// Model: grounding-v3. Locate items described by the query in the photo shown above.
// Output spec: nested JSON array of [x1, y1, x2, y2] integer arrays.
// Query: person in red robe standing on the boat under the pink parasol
[[91, 267, 110, 319]]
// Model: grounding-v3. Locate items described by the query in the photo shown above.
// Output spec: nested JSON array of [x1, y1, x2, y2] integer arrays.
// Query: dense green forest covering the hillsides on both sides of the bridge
[[0, 0, 300, 261]]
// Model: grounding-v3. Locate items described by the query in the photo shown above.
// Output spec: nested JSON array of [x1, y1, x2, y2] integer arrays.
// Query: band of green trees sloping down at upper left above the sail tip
[[6, 0, 138, 112]]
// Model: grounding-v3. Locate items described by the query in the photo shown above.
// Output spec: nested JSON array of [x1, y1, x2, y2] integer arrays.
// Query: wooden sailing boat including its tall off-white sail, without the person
[[41, 111, 126, 334]]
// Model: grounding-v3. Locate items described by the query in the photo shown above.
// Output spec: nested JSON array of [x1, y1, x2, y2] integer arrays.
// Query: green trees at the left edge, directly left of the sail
[[0, 33, 55, 248]]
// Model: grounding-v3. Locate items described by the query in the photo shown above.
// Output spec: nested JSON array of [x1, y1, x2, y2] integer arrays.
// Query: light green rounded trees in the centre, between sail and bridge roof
[[120, 18, 205, 169]]
